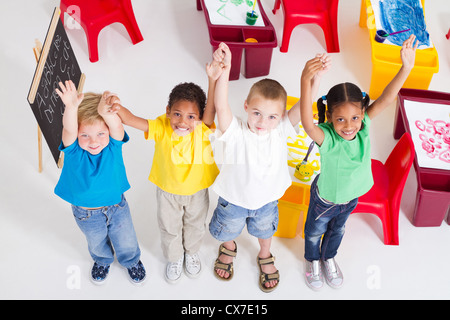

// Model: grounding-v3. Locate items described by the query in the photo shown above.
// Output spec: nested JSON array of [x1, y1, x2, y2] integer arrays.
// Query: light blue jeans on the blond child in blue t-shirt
[[72, 195, 141, 268]]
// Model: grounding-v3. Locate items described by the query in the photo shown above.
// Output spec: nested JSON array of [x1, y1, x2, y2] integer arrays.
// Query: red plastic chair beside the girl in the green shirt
[[352, 132, 415, 245]]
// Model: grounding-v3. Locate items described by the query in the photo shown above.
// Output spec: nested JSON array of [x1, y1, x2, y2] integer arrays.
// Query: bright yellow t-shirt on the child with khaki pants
[[145, 114, 219, 195]]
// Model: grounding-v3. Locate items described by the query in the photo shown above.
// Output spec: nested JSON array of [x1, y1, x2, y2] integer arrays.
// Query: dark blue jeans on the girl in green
[[305, 176, 358, 261]]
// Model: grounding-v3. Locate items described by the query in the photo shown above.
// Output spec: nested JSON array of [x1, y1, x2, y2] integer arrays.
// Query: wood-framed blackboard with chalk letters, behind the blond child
[[28, 8, 84, 163]]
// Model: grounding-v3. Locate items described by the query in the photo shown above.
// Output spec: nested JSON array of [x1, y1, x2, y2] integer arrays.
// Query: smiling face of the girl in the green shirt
[[327, 102, 364, 141]]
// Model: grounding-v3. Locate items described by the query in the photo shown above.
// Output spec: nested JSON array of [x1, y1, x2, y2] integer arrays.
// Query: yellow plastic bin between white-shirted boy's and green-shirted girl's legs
[[274, 182, 310, 238]]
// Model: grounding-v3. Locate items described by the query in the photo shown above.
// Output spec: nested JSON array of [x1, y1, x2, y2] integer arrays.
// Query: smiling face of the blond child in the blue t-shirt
[[78, 120, 109, 155]]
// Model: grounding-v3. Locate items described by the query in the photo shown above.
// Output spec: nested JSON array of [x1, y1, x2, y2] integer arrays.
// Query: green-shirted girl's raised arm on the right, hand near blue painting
[[367, 34, 419, 119]]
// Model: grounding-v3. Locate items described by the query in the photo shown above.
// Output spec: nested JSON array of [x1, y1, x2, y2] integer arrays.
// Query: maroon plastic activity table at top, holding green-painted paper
[[197, 0, 278, 80]]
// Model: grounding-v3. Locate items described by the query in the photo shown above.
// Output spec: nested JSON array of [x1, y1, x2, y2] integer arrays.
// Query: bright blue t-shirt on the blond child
[[55, 133, 130, 208]]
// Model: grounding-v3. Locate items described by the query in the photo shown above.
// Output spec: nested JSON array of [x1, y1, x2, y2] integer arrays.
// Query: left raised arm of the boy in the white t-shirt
[[213, 42, 233, 133]]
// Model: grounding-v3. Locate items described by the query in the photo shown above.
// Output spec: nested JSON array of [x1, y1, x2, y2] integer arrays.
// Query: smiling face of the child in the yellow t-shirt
[[166, 100, 201, 137]]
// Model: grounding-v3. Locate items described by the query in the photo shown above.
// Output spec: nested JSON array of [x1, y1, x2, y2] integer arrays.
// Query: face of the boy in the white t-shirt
[[244, 95, 285, 135]]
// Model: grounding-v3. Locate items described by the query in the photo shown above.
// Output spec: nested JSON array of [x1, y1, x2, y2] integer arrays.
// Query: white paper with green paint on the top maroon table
[[204, 0, 264, 27]]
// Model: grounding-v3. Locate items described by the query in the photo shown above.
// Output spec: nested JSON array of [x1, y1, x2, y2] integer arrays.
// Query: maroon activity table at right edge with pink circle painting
[[394, 89, 450, 227]]
